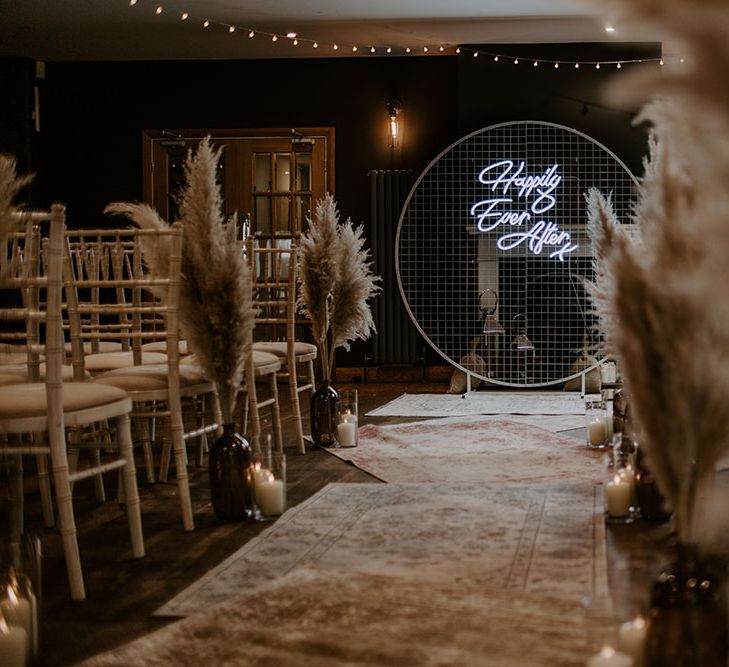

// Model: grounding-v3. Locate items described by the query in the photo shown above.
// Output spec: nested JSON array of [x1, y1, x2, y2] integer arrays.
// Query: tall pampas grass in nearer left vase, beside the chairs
[[106, 137, 256, 423]]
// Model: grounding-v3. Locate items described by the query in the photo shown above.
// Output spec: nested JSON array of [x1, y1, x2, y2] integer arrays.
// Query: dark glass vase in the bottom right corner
[[645, 544, 729, 667]]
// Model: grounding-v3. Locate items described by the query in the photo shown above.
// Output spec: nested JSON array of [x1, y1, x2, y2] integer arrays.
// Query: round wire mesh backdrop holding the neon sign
[[395, 121, 636, 386]]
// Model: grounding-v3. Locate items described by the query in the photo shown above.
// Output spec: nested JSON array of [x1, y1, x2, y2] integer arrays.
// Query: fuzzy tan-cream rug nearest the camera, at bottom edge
[[83, 568, 592, 667]]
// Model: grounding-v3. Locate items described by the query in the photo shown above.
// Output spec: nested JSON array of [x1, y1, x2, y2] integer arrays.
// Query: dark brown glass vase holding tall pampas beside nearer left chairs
[[209, 424, 254, 521]]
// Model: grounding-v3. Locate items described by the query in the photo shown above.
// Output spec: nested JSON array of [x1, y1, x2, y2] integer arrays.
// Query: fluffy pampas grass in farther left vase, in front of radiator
[[299, 193, 380, 378]]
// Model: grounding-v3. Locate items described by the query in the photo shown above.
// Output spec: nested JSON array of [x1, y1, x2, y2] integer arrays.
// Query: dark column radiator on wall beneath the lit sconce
[[369, 169, 422, 365]]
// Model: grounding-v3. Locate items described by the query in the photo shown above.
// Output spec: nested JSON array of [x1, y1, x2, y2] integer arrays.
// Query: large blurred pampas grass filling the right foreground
[[588, 13, 729, 544]]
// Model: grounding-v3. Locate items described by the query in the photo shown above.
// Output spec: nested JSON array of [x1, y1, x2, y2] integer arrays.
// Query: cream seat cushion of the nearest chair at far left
[[0, 382, 127, 419]]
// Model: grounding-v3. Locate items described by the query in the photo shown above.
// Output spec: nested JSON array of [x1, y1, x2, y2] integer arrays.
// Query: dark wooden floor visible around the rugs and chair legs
[[0, 383, 669, 666]]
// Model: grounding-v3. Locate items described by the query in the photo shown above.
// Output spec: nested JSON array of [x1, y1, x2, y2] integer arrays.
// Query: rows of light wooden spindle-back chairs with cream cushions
[[0, 205, 316, 600]]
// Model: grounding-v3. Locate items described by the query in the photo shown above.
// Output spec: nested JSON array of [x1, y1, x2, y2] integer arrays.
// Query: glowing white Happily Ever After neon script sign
[[470, 160, 579, 262]]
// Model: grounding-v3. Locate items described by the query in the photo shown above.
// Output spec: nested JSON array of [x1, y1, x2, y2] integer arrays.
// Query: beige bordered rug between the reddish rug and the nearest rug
[[156, 483, 607, 616]]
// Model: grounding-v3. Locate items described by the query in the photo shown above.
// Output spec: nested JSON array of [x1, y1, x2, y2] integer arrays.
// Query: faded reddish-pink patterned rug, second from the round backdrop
[[327, 417, 607, 483]]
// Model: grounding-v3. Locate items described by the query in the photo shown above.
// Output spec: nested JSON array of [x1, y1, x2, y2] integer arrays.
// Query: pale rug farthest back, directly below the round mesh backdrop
[[367, 391, 596, 418]]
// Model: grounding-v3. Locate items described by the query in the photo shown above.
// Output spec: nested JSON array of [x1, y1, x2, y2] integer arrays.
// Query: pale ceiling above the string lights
[[0, 0, 662, 61]]
